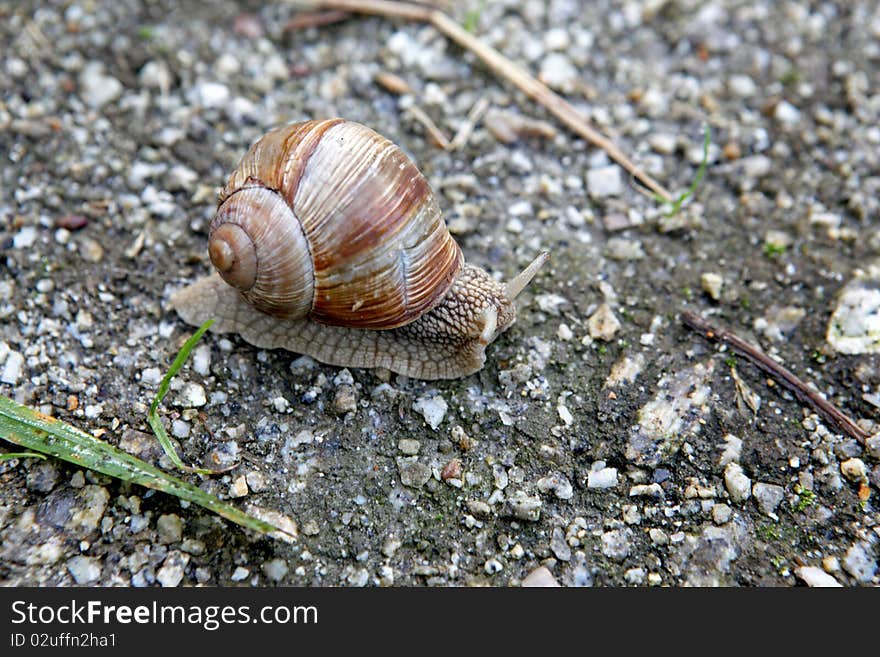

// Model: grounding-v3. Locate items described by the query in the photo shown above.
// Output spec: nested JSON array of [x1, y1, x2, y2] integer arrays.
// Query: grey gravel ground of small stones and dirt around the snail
[[0, 0, 880, 586]]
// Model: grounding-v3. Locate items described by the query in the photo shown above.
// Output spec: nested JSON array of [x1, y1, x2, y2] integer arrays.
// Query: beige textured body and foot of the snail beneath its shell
[[171, 265, 516, 379]]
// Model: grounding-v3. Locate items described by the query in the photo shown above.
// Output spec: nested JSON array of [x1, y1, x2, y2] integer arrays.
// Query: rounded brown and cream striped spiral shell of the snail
[[208, 119, 464, 329]]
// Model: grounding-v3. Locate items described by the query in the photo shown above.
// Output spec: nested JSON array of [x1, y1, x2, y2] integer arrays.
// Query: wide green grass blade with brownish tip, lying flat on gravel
[[0, 395, 292, 539]]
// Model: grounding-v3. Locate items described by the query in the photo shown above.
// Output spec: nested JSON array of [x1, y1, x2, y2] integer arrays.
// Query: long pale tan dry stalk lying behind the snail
[[299, 0, 673, 203]]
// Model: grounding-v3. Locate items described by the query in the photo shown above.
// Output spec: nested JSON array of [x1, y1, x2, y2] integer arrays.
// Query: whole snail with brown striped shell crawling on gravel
[[171, 119, 548, 379]]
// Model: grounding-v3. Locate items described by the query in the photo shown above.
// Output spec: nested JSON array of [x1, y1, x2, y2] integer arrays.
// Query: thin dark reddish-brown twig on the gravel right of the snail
[[681, 311, 869, 444]]
